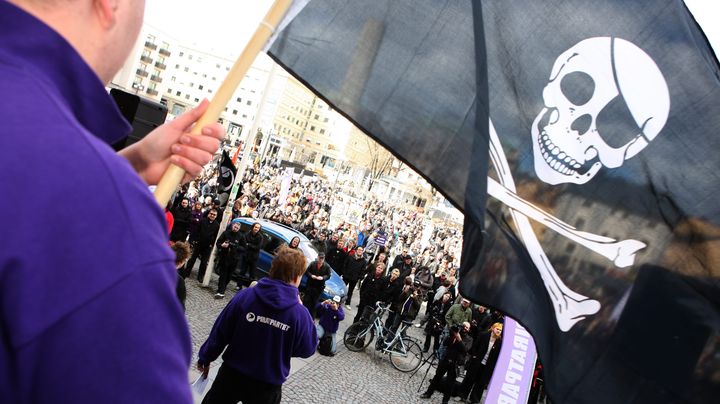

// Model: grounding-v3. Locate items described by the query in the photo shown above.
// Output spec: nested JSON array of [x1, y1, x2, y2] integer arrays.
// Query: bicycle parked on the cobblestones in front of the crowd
[[343, 302, 423, 373]]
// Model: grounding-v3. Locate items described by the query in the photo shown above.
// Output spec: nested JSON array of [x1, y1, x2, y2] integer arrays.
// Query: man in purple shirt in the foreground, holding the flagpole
[[0, 0, 224, 403]]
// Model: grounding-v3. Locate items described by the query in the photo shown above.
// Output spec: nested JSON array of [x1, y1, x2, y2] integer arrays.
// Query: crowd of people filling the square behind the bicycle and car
[[168, 157, 503, 403]]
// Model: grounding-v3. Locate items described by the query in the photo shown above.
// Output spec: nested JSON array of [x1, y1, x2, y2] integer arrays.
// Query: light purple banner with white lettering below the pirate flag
[[485, 317, 537, 404]]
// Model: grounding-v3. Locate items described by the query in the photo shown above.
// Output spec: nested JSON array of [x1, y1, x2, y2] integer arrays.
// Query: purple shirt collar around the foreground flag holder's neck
[[0, 0, 132, 144]]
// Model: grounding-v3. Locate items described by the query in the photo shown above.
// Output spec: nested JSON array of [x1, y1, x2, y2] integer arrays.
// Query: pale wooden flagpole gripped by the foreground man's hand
[[155, 0, 293, 207]]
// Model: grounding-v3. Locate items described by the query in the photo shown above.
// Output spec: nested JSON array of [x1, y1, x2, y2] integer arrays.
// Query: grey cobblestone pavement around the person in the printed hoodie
[[185, 272, 458, 404]]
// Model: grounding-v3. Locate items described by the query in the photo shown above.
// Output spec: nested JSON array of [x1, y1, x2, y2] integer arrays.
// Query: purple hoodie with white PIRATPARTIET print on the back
[[198, 278, 318, 386]]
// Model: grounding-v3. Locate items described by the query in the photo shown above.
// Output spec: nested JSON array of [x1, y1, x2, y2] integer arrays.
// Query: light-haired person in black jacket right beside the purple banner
[[458, 323, 503, 403]]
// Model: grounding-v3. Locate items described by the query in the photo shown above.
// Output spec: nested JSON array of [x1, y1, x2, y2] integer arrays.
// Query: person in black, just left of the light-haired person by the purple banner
[[420, 323, 470, 404]]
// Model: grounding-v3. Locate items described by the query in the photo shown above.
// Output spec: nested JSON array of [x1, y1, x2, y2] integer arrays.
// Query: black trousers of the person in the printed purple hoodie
[[202, 364, 282, 404]]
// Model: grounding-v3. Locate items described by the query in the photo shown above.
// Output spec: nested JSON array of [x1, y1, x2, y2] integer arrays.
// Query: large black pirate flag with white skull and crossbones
[[271, 0, 720, 403]]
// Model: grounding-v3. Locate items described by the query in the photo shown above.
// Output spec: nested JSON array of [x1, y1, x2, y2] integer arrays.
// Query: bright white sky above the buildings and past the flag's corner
[[145, 0, 720, 58]]
